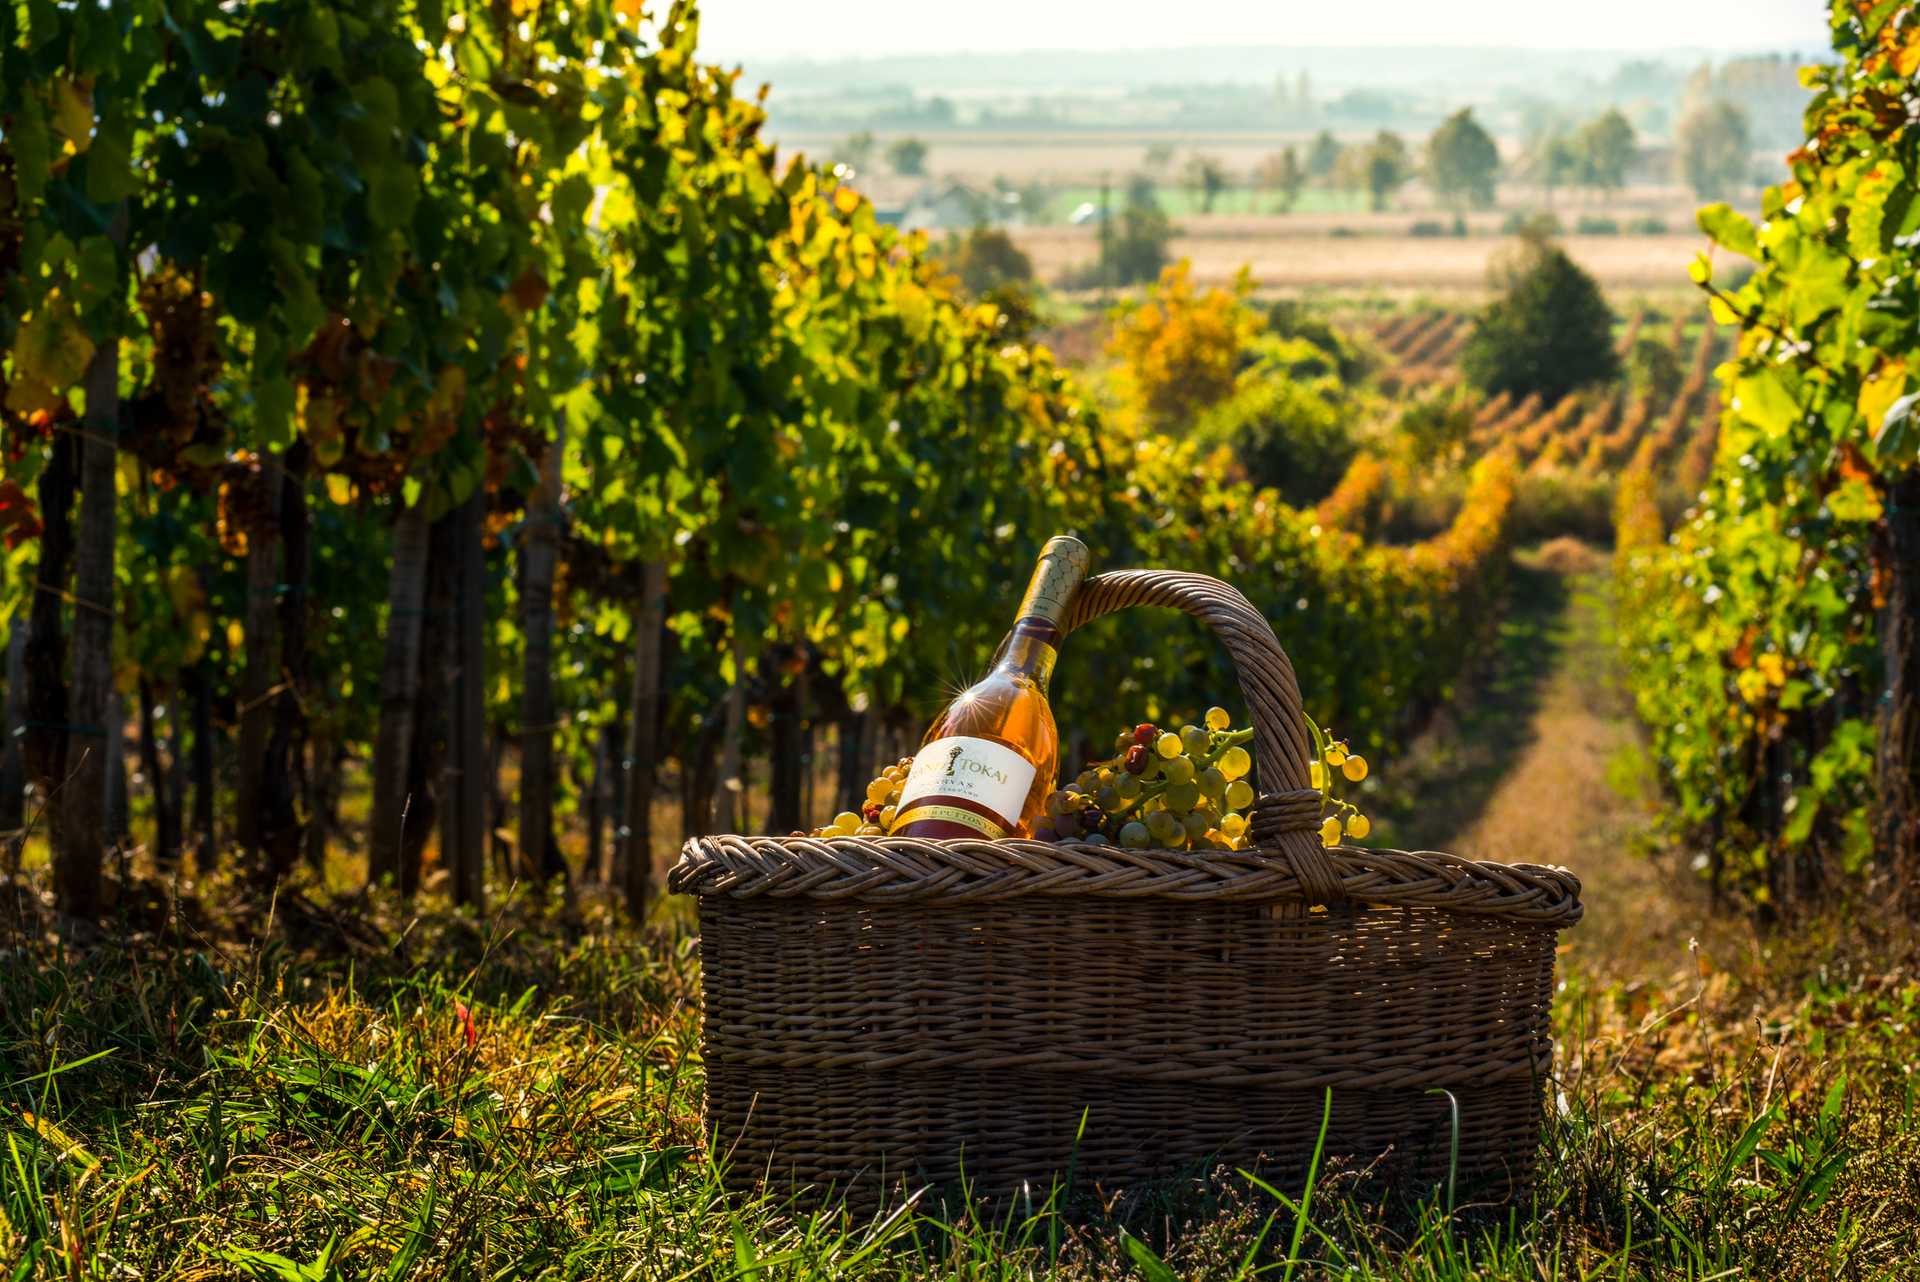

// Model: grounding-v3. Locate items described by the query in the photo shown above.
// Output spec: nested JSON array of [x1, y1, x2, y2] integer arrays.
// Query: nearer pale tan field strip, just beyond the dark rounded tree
[[1014, 217, 1705, 290]]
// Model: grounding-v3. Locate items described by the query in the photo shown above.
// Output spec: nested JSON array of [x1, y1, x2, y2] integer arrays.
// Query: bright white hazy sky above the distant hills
[[701, 0, 1828, 59]]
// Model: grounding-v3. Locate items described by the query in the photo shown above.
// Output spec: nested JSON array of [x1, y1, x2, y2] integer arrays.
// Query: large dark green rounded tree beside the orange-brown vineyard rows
[[1461, 236, 1620, 401]]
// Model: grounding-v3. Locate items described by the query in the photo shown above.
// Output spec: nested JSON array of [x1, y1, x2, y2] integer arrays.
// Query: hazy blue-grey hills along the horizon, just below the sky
[[743, 46, 1811, 150]]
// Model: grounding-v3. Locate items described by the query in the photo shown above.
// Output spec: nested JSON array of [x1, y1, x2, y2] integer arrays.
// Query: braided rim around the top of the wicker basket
[[668, 835, 1584, 929]]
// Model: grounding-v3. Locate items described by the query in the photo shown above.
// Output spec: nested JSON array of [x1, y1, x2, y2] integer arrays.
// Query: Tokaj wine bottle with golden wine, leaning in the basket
[[889, 534, 1089, 841]]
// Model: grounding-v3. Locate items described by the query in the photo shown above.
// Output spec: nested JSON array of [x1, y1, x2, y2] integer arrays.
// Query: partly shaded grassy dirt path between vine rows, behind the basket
[[1392, 539, 1743, 985]]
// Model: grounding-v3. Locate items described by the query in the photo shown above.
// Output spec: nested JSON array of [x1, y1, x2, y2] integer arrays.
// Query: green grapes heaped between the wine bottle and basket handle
[[1033, 708, 1254, 850]]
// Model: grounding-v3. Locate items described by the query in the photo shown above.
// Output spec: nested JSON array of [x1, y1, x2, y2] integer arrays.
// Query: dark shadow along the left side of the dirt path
[[1367, 553, 1574, 854]]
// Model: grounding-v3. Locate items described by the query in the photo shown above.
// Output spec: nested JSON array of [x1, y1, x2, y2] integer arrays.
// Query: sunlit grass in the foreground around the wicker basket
[[0, 875, 1920, 1282]]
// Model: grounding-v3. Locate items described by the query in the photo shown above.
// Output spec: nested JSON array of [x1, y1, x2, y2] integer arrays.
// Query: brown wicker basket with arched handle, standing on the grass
[[670, 570, 1580, 1205]]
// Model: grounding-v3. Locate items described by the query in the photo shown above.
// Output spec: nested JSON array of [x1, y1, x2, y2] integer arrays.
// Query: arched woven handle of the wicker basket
[[1064, 570, 1346, 904]]
